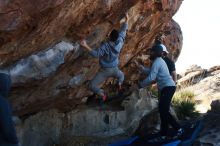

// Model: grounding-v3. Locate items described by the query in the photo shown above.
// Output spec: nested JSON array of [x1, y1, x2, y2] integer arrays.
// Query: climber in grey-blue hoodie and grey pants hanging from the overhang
[[80, 13, 129, 101]]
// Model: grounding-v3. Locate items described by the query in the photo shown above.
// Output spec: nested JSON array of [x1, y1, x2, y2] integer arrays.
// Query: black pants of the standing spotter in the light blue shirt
[[159, 86, 180, 136]]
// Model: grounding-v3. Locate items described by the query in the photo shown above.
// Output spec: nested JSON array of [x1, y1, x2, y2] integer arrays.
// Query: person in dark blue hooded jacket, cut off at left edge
[[0, 73, 19, 146]]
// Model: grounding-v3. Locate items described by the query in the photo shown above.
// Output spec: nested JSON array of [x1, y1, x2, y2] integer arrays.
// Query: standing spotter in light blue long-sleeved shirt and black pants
[[136, 45, 184, 143]]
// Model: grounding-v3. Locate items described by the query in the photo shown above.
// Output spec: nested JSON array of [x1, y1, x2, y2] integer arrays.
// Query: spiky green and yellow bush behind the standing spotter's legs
[[172, 91, 199, 120]]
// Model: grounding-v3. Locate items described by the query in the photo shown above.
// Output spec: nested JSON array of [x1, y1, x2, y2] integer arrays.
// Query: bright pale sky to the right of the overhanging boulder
[[173, 0, 220, 73]]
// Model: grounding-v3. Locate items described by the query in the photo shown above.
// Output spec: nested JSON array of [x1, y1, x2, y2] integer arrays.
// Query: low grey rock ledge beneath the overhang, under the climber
[[17, 89, 158, 146]]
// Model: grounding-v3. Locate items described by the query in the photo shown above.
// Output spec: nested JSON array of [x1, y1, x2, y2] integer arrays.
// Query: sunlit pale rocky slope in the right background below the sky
[[178, 66, 220, 113]]
